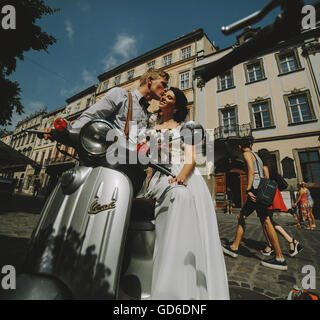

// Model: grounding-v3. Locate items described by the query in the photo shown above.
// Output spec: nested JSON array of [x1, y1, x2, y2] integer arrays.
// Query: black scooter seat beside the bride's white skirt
[[129, 198, 155, 231]]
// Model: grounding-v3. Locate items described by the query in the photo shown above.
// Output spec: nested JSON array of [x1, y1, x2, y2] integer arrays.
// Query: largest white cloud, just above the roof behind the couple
[[102, 33, 137, 70]]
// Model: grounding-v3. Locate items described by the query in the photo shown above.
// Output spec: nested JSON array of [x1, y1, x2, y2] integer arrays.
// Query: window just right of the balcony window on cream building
[[249, 99, 274, 129]]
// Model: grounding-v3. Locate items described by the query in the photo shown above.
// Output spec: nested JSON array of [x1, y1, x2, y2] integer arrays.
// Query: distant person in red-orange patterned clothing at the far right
[[293, 182, 316, 230]]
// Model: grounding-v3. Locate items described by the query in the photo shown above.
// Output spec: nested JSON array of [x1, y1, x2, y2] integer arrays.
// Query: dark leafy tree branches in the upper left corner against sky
[[0, 0, 59, 126]]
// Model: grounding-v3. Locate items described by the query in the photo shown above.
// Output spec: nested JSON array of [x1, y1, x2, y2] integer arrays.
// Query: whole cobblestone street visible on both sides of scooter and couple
[[0, 196, 320, 300]]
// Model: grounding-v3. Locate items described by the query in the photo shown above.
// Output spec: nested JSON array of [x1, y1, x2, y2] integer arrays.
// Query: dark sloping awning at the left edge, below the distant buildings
[[0, 141, 39, 172]]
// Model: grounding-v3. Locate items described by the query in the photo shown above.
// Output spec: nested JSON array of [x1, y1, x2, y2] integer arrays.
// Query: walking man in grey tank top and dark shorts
[[222, 138, 288, 270]]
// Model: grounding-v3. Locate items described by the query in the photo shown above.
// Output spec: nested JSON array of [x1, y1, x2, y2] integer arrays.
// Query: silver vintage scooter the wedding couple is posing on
[[2, 119, 202, 300]]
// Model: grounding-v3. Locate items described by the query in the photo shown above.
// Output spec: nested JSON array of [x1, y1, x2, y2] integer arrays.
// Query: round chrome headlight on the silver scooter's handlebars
[[80, 119, 115, 157]]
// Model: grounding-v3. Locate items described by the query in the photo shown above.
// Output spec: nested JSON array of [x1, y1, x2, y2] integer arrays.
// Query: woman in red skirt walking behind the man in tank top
[[258, 149, 302, 257]]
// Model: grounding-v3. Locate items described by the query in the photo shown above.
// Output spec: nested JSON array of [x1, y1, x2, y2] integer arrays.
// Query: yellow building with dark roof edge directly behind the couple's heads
[[96, 29, 216, 119]]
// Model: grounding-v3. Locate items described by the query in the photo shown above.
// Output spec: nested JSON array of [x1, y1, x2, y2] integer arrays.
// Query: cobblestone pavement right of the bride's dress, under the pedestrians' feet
[[217, 213, 320, 299]]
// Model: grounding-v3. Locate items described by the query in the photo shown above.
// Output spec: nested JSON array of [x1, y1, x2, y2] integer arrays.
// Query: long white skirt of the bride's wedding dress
[[143, 164, 229, 300]]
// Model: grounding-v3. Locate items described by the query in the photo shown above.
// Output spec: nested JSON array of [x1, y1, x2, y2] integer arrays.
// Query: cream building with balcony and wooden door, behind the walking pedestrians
[[195, 28, 320, 214]]
